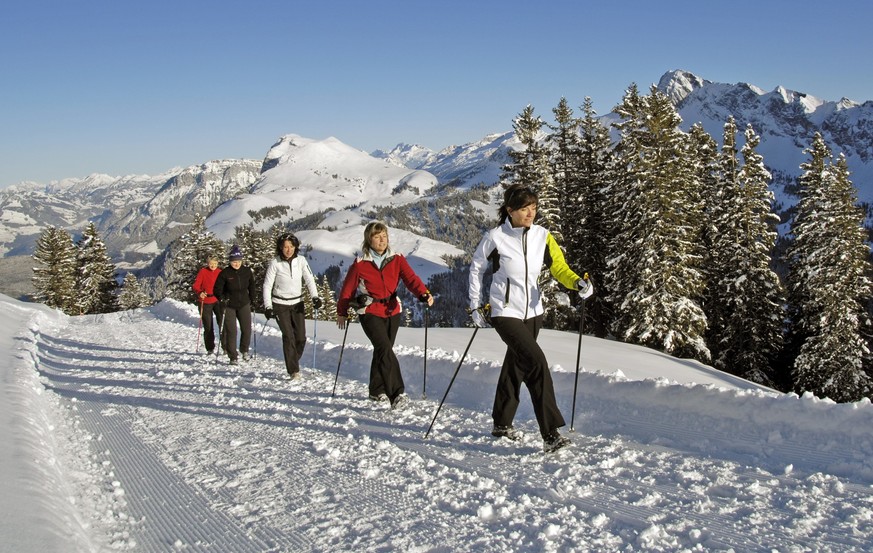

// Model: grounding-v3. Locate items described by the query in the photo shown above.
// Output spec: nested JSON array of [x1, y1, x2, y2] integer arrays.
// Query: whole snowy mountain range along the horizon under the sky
[[0, 70, 873, 278]]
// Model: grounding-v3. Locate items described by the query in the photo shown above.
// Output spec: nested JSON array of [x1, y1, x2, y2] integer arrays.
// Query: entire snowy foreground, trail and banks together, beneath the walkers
[[6, 292, 873, 552]]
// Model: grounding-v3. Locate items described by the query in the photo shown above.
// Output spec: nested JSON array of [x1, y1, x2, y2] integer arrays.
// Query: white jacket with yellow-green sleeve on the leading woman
[[470, 219, 580, 320]]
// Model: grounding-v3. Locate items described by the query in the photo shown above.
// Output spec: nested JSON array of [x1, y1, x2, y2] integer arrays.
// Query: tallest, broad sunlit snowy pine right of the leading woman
[[608, 86, 709, 360]]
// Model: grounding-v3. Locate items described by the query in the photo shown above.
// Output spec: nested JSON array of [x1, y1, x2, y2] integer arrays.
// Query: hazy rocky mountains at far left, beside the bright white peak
[[0, 160, 261, 263]]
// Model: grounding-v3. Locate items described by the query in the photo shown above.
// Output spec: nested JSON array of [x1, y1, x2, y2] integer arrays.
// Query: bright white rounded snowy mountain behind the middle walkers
[[206, 134, 462, 279]]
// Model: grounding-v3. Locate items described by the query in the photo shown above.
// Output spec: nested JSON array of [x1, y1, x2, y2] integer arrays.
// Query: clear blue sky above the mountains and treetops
[[0, 0, 873, 187]]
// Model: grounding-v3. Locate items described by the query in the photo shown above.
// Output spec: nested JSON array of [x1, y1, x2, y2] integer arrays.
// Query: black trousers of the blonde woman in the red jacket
[[360, 314, 405, 402]]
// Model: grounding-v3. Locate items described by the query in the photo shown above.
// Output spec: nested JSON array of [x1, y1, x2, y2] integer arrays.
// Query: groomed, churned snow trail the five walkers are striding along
[[30, 311, 873, 552]]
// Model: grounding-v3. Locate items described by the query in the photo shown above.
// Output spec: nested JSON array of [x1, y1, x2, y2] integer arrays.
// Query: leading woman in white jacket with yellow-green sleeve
[[470, 185, 593, 451]]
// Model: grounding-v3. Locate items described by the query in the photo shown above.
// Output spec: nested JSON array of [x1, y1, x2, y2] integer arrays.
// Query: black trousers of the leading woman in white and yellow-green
[[491, 316, 566, 438]]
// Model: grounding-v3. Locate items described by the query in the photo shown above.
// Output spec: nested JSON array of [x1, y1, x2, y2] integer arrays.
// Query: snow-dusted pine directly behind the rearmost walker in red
[[164, 213, 227, 303]]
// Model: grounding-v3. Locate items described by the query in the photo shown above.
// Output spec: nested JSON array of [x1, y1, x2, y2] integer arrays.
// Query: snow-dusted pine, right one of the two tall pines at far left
[[76, 222, 118, 314]]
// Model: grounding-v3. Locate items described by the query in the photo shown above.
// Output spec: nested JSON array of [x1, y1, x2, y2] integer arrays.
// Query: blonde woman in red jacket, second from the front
[[336, 221, 433, 409]]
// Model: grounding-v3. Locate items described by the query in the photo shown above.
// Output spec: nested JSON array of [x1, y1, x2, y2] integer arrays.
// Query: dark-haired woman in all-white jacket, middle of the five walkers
[[263, 234, 321, 380]]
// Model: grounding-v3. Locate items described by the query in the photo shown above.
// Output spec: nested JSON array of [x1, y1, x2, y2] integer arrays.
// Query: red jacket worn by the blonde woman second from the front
[[336, 250, 427, 318]]
